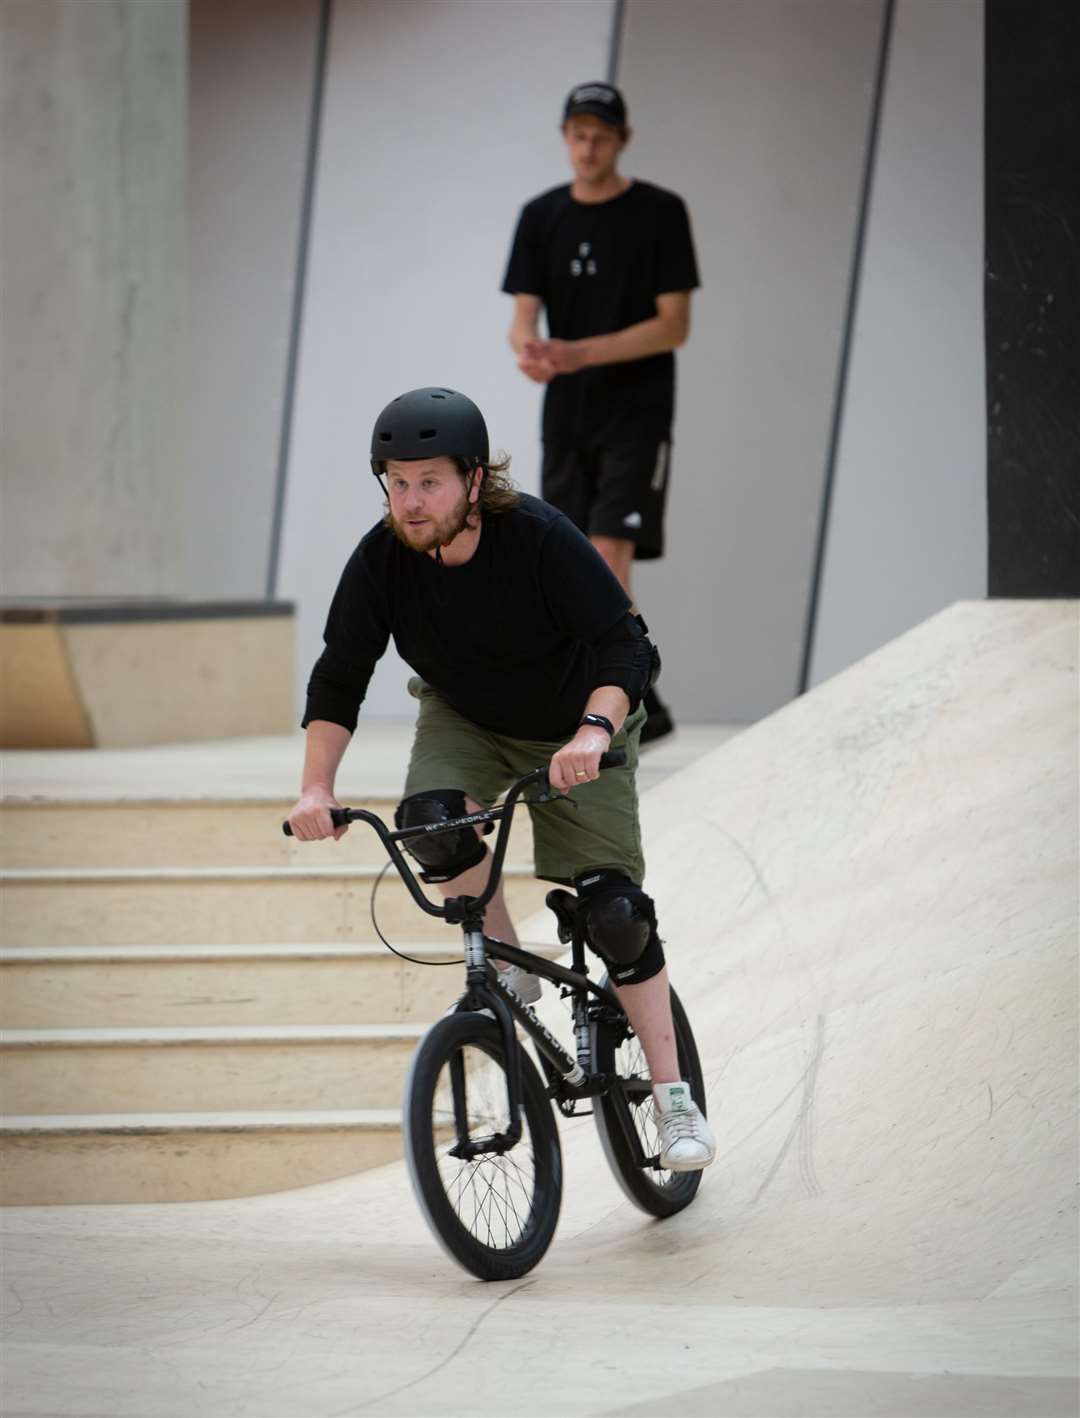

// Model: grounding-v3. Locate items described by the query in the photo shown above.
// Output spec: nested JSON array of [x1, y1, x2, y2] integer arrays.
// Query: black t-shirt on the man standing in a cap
[[503, 182, 700, 447]]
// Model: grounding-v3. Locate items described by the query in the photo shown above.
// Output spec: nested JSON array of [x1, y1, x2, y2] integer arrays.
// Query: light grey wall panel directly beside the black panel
[[811, 0, 986, 683]]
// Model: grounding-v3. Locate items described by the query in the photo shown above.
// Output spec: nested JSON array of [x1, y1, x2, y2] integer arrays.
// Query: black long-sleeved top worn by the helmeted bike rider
[[303, 495, 635, 739]]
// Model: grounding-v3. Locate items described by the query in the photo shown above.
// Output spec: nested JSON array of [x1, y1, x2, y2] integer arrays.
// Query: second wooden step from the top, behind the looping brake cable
[[0, 866, 549, 946]]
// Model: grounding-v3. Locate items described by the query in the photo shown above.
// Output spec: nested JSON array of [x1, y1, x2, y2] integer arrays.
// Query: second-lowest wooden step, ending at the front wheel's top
[[0, 1024, 424, 1115]]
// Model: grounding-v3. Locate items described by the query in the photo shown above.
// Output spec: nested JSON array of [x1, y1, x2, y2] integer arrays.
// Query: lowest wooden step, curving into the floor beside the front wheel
[[0, 1109, 403, 1207]]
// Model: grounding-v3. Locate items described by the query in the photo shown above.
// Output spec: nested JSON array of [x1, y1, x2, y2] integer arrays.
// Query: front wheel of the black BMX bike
[[404, 1012, 563, 1280]]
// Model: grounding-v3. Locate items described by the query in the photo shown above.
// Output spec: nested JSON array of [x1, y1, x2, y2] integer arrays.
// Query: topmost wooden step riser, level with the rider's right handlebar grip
[[0, 798, 533, 869]]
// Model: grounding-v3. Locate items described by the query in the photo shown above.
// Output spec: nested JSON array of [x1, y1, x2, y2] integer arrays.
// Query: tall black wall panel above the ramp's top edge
[[986, 0, 1080, 597]]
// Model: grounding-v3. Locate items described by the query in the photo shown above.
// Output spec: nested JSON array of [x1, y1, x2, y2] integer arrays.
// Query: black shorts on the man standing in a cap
[[540, 438, 672, 562]]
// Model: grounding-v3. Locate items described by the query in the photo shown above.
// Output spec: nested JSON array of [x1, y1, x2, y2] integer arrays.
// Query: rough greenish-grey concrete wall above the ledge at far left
[[0, 0, 187, 597]]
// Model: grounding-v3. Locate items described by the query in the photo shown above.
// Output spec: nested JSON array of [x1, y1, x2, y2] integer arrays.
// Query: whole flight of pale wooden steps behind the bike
[[0, 722, 730, 1204]]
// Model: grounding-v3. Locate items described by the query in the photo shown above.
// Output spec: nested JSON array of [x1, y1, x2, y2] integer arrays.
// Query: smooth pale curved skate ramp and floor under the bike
[[7, 603, 1077, 1418]]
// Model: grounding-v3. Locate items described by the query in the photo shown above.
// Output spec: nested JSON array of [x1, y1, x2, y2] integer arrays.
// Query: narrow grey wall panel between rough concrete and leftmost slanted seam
[[186, 0, 319, 597]]
